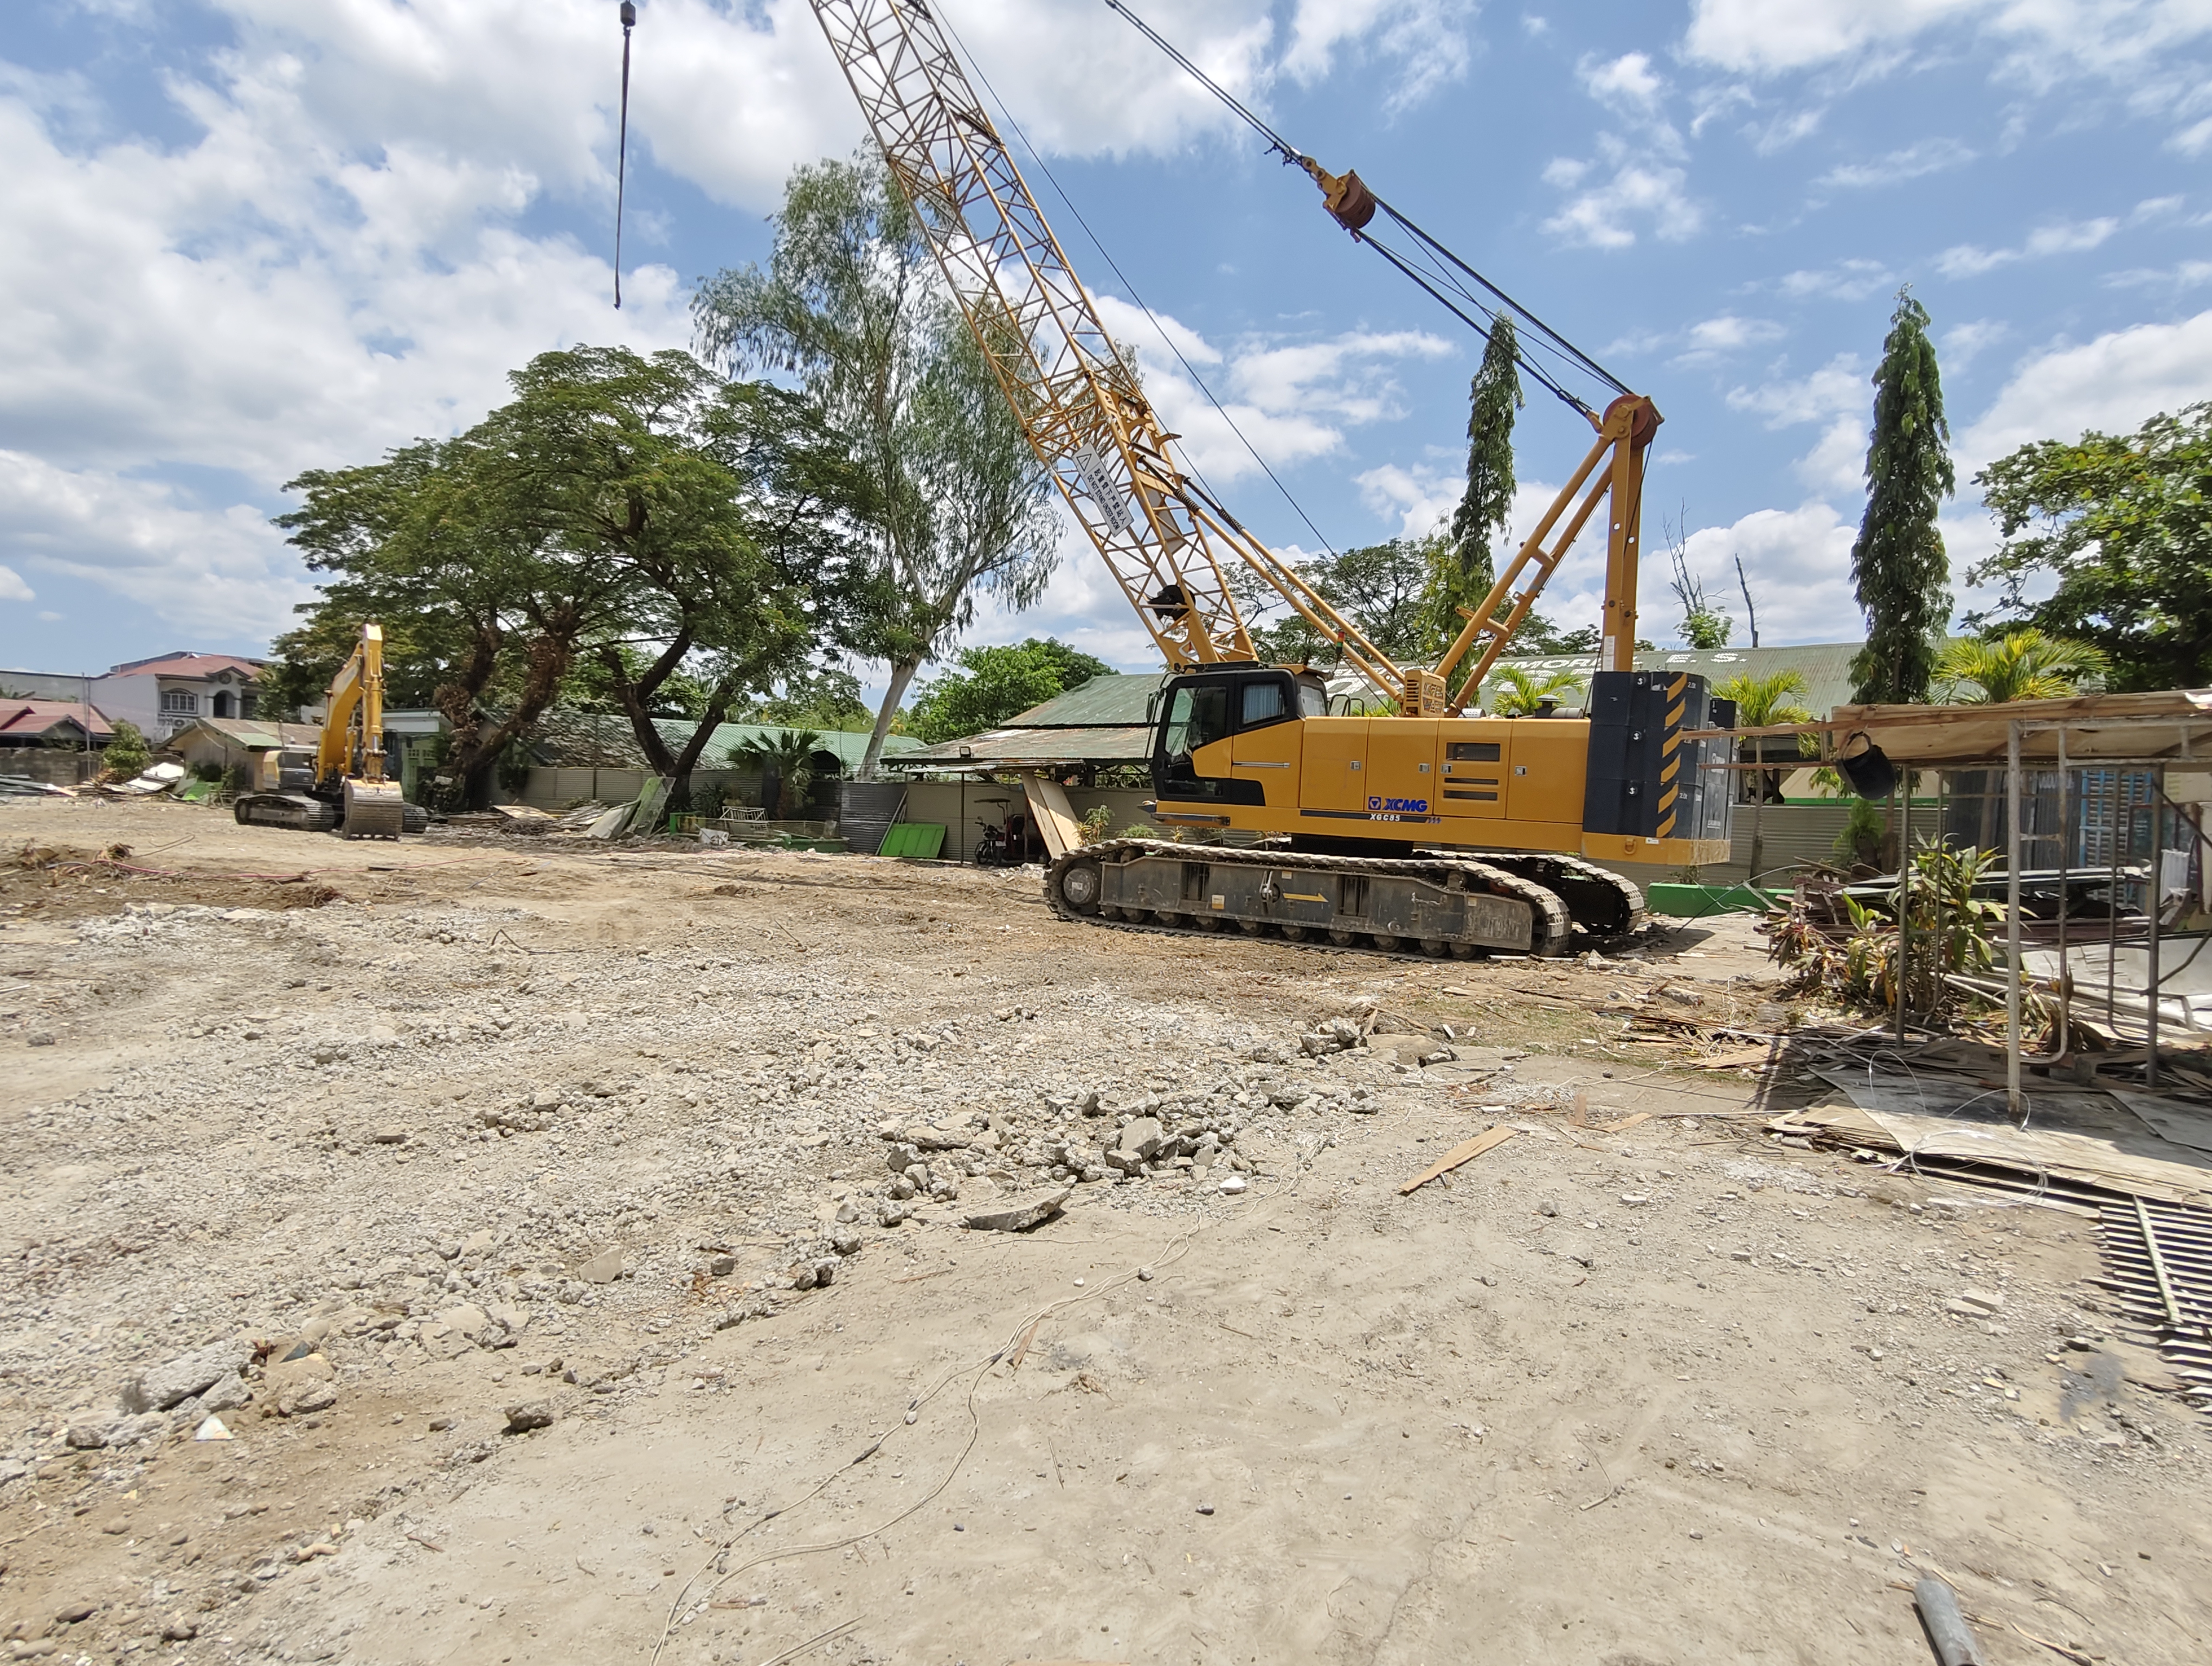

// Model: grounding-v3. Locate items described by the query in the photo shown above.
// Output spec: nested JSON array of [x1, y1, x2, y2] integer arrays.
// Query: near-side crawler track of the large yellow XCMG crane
[[1044, 838, 1584, 958]]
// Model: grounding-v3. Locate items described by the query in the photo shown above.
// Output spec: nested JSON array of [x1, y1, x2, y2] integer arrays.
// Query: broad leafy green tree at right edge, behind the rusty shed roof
[[1966, 403, 2212, 690]]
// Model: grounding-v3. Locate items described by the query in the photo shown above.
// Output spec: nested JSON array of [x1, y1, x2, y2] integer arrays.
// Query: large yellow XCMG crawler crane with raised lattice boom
[[812, 0, 1730, 956]]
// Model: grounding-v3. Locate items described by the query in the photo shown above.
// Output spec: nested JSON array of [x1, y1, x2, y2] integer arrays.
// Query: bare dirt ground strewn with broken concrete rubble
[[0, 801, 2212, 1666]]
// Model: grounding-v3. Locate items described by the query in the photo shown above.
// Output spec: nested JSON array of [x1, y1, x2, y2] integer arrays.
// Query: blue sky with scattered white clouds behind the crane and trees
[[0, 0, 2212, 670]]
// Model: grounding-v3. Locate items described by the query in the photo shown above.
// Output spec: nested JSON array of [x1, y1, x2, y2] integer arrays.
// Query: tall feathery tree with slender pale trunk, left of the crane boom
[[692, 155, 1059, 779]]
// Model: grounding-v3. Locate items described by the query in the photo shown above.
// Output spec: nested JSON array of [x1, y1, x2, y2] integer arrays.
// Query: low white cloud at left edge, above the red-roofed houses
[[0, 451, 307, 642]]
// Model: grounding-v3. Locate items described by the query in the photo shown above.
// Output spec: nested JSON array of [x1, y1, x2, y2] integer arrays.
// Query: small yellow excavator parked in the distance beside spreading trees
[[232, 624, 429, 838]]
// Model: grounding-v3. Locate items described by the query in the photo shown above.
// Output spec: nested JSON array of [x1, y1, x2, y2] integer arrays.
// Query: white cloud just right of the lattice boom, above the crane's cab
[[1095, 294, 1456, 484]]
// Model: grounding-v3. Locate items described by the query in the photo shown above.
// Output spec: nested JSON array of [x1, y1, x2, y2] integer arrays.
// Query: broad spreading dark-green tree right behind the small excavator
[[274, 348, 838, 803]]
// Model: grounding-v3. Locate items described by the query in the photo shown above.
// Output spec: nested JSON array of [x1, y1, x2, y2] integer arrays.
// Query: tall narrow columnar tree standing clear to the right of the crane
[[1851, 285, 1953, 703]]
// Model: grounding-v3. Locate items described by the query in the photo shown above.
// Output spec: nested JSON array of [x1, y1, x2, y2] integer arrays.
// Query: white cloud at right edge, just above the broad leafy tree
[[1958, 312, 2212, 462]]
